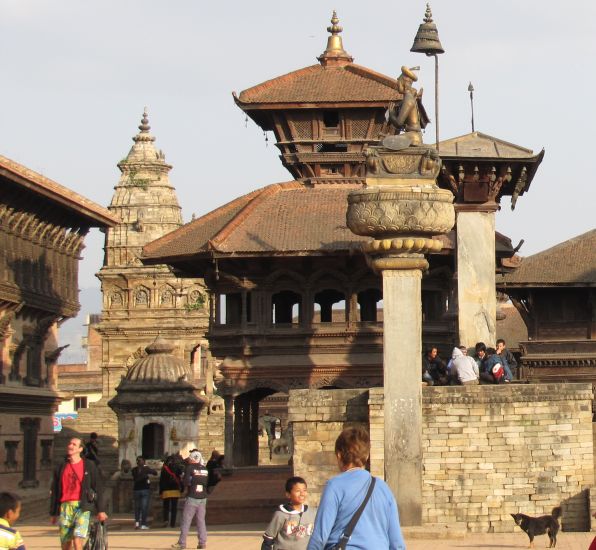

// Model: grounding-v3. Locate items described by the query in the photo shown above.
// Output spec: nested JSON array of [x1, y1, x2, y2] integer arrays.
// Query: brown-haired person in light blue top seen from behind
[[308, 427, 406, 550]]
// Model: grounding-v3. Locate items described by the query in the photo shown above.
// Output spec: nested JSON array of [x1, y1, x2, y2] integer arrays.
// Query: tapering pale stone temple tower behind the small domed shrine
[[65, 111, 209, 470]]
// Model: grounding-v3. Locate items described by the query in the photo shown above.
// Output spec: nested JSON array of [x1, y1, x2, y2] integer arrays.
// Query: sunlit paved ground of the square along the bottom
[[14, 522, 594, 550]]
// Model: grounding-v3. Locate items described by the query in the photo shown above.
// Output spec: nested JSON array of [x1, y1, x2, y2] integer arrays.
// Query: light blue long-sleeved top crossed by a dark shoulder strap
[[308, 469, 406, 550]]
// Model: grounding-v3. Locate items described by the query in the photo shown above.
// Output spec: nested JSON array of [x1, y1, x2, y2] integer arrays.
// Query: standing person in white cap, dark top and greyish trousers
[[172, 449, 209, 549]]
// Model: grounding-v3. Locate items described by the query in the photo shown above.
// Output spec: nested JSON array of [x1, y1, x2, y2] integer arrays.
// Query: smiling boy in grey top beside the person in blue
[[261, 477, 316, 550]]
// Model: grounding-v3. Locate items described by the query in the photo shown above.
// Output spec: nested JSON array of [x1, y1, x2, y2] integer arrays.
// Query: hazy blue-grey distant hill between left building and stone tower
[[58, 287, 101, 365]]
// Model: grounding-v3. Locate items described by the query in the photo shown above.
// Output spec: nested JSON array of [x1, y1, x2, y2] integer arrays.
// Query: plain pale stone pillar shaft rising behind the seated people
[[457, 204, 497, 347]]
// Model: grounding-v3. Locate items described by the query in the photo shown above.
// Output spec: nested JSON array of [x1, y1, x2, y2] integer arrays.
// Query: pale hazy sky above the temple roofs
[[0, 0, 596, 362]]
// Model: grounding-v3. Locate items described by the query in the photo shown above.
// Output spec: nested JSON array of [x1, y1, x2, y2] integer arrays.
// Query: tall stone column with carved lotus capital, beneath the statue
[[347, 146, 455, 526]]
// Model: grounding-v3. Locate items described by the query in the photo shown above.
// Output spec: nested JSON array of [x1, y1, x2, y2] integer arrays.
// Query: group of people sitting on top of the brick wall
[[422, 338, 517, 386]]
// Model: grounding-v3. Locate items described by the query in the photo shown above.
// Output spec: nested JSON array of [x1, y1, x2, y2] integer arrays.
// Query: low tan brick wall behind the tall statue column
[[289, 384, 594, 532]]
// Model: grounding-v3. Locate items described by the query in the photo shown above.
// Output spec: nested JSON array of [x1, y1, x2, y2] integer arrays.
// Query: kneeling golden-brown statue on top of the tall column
[[383, 66, 422, 150]]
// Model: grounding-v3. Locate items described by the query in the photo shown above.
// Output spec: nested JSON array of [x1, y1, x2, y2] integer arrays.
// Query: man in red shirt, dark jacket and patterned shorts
[[50, 437, 108, 550]]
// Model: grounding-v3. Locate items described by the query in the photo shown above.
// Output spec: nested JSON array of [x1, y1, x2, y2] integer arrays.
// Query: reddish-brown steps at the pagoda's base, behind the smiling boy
[[207, 465, 293, 525]]
